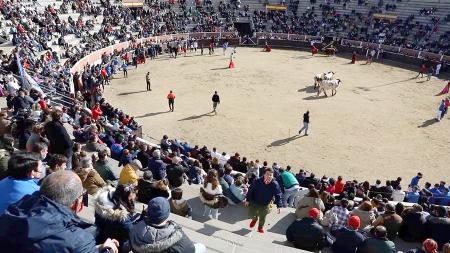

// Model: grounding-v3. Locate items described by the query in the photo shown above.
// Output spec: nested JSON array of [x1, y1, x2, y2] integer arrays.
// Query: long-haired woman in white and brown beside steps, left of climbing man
[[200, 169, 223, 219]]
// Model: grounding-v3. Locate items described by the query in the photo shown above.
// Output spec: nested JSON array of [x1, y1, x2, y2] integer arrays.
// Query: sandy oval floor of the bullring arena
[[105, 48, 450, 186]]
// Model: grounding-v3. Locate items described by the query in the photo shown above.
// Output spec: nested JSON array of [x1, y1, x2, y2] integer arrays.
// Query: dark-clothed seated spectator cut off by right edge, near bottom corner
[[424, 206, 450, 250]]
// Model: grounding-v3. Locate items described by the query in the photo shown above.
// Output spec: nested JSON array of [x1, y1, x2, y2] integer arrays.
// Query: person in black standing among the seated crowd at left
[[44, 110, 73, 170]]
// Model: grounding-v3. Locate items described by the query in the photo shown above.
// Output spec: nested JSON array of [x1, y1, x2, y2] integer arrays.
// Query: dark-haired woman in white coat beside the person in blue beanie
[[94, 185, 139, 252]]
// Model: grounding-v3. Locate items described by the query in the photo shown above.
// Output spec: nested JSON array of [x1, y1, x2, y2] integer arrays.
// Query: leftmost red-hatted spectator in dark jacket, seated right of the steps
[[286, 208, 331, 251]]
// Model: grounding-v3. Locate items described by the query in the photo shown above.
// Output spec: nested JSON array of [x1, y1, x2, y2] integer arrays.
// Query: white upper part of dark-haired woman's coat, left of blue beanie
[[95, 189, 130, 221]]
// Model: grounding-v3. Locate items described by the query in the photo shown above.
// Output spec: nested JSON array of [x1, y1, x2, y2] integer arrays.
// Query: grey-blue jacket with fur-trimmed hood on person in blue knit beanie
[[130, 219, 187, 253]]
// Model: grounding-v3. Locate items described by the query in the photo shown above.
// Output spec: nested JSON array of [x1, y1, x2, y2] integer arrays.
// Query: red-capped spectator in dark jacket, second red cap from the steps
[[331, 215, 365, 253]]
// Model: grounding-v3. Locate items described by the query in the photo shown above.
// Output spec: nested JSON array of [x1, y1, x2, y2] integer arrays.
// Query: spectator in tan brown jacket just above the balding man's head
[[74, 154, 106, 195]]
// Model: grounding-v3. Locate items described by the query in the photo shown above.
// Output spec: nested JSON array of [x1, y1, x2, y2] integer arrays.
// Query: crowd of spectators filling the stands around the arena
[[0, 0, 450, 253]]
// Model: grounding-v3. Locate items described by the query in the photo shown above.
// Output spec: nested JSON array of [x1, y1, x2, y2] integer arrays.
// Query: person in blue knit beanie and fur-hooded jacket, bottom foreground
[[129, 197, 206, 253]]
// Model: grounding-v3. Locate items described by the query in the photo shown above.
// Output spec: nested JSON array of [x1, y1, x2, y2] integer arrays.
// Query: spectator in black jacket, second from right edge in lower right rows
[[398, 204, 426, 242]]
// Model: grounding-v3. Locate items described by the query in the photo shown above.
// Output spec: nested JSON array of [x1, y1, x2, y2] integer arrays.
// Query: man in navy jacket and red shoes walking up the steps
[[245, 167, 283, 233]]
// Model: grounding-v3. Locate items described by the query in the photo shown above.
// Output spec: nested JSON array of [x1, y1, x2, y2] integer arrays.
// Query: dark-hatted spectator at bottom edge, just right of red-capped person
[[357, 226, 397, 253]]
